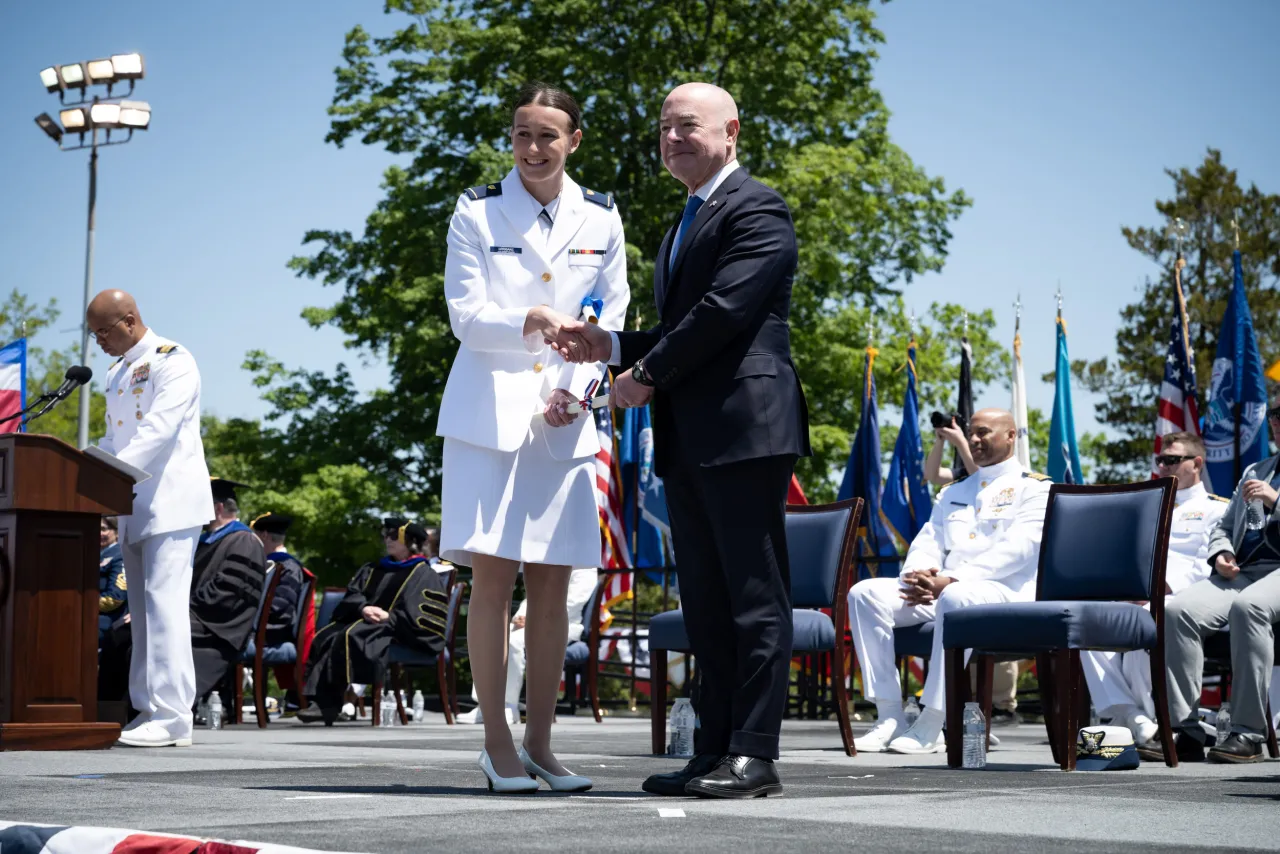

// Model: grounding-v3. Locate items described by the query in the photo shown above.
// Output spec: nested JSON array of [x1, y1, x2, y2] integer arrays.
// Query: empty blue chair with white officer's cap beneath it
[[942, 478, 1178, 771]]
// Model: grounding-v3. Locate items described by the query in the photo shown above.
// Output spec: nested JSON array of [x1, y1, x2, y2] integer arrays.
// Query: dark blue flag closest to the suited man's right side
[[837, 347, 897, 579]]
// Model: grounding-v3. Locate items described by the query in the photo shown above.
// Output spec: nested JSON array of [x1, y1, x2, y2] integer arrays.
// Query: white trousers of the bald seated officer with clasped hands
[[849, 579, 1015, 713]]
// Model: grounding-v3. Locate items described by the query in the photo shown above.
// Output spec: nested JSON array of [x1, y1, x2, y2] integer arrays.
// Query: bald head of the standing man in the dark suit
[[660, 83, 741, 193]]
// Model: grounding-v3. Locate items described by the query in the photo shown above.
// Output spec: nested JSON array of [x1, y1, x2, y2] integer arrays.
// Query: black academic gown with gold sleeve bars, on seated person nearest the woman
[[302, 554, 449, 708]]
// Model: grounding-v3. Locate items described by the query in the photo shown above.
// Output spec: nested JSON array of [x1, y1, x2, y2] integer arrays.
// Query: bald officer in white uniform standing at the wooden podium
[[86, 291, 214, 748]]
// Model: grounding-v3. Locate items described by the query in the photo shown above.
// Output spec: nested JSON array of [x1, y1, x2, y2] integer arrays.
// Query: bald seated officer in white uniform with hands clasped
[[849, 410, 1048, 753]]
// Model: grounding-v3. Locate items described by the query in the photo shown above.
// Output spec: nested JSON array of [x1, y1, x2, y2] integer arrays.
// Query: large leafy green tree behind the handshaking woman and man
[[272, 0, 969, 506]]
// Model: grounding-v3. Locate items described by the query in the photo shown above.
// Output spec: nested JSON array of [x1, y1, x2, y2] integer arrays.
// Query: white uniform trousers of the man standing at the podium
[[120, 528, 200, 739]]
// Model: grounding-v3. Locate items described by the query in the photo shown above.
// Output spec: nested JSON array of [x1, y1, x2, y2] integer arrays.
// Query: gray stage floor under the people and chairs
[[0, 716, 1280, 854]]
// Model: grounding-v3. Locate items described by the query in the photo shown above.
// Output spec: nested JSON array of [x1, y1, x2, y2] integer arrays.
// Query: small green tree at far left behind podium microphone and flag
[[0, 288, 106, 444]]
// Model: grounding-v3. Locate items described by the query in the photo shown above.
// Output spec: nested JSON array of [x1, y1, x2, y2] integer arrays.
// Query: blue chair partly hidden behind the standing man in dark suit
[[649, 498, 863, 757]]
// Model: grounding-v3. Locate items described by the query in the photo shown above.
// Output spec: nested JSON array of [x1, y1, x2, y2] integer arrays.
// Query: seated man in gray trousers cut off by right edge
[[1139, 388, 1280, 763]]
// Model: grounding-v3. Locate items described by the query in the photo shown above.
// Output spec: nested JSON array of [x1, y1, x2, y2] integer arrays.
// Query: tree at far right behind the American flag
[[1071, 149, 1280, 481]]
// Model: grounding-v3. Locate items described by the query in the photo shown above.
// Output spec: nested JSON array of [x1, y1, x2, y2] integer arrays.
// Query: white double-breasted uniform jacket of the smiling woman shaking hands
[[436, 169, 631, 460]]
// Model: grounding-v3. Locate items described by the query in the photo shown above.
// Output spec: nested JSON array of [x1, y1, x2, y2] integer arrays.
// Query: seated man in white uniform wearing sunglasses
[[1080, 433, 1228, 746]]
